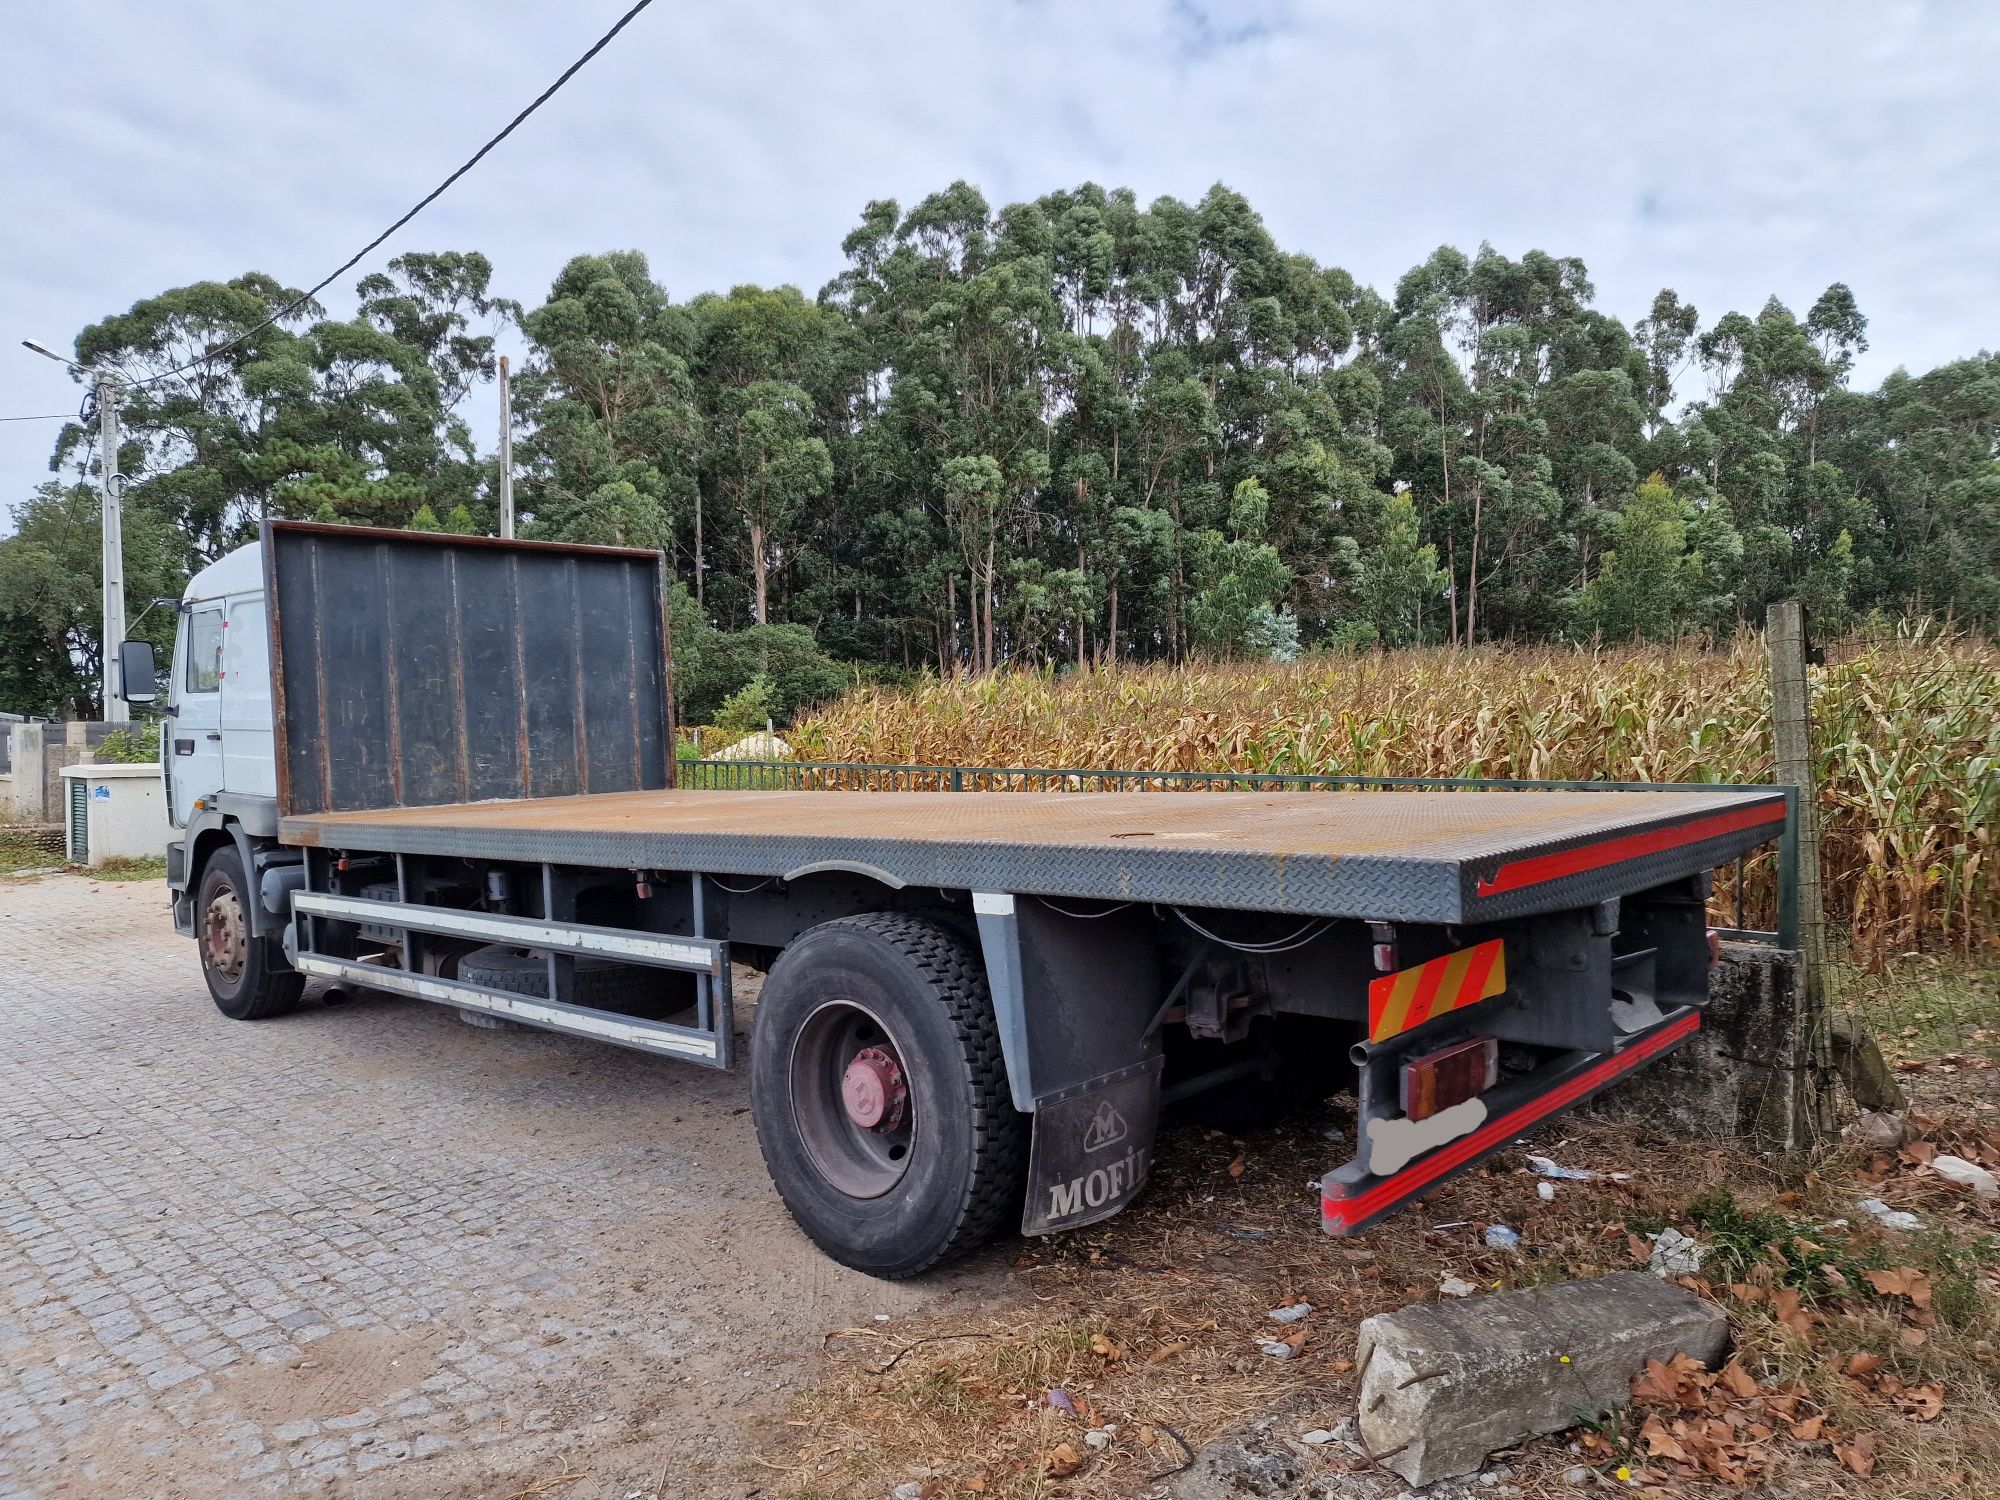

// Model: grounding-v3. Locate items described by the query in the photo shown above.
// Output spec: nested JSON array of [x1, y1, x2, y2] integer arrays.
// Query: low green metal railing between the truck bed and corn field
[[678, 760, 1798, 948]]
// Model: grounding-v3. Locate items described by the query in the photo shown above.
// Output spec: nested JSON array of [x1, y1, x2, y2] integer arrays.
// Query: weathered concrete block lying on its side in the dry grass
[[1356, 1270, 1728, 1484]]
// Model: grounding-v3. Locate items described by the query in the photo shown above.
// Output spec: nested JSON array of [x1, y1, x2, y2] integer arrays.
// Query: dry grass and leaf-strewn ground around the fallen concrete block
[[780, 1118, 2000, 1500]]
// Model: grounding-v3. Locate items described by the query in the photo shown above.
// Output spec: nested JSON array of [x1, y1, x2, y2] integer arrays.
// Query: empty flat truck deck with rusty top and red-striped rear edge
[[280, 790, 1784, 922]]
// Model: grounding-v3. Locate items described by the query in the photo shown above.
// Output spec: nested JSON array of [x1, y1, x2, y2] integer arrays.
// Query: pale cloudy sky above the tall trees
[[0, 0, 2000, 524]]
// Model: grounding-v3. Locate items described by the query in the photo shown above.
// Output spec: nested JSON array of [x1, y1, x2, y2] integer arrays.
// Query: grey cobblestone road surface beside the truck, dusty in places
[[0, 876, 990, 1500]]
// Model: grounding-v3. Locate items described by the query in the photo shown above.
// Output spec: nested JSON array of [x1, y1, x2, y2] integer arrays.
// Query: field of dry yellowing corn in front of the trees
[[794, 624, 2000, 966]]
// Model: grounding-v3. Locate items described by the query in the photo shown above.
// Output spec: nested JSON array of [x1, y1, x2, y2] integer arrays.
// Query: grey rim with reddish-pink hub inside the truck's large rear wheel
[[792, 1000, 918, 1198]]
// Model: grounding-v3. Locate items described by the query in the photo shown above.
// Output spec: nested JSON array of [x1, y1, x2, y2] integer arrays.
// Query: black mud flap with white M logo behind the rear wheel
[[1020, 1058, 1166, 1234]]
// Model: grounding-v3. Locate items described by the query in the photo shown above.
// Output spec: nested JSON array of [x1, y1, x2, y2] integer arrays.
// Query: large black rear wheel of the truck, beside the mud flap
[[750, 912, 1028, 1280]]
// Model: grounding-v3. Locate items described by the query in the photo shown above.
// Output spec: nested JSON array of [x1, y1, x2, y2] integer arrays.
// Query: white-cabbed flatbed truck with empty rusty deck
[[122, 520, 1786, 1278]]
